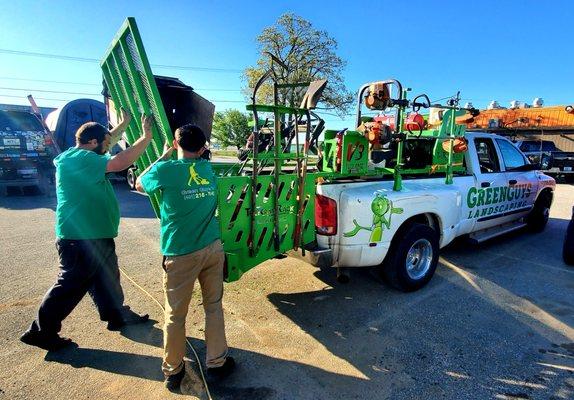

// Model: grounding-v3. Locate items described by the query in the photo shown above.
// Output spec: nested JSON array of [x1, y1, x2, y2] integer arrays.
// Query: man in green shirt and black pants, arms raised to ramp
[[20, 111, 152, 350]]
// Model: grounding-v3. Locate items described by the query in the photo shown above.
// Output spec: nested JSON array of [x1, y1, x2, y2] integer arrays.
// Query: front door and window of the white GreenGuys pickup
[[495, 138, 538, 220]]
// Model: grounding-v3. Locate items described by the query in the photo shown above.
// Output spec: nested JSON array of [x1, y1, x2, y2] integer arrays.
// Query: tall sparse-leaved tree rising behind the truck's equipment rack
[[244, 13, 354, 116]]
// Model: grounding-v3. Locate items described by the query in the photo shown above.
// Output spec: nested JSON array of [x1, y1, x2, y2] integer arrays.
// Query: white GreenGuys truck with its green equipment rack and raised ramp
[[101, 18, 555, 291]]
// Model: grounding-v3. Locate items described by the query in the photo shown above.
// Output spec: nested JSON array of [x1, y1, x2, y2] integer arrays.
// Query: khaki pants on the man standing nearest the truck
[[162, 240, 227, 376]]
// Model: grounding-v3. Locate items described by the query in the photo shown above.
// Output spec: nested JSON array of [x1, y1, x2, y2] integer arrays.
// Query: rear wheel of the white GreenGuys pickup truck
[[381, 223, 439, 292]]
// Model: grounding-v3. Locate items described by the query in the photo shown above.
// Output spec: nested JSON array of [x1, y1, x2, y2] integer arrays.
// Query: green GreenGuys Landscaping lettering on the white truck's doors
[[466, 183, 532, 219]]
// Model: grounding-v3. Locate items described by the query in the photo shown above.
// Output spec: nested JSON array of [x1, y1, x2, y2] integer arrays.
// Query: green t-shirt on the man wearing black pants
[[54, 147, 120, 239]]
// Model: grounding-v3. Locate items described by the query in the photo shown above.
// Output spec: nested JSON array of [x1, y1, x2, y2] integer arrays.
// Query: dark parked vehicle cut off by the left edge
[[0, 110, 55, 188]]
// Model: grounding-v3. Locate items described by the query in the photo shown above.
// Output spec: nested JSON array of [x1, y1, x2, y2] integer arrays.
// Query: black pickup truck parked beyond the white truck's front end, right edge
[[515, 140, 574, 176]]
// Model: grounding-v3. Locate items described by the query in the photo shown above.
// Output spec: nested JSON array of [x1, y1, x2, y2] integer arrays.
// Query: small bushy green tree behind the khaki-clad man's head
[[211, 110, 251, 149]]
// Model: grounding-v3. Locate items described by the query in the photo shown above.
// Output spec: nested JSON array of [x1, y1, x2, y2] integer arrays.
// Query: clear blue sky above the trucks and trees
[[0, 0, 574, 128]]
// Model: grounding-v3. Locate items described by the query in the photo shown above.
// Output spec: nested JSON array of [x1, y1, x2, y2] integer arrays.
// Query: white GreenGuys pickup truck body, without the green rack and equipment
[[307, 132, 556, 291]]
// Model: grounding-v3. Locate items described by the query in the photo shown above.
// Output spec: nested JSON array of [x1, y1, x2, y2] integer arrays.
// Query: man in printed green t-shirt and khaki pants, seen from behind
[[136, 125, 235, 391]]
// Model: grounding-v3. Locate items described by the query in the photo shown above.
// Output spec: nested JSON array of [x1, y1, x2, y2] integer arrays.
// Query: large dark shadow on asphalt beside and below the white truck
[[268, 219, 574, 399]]
